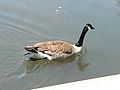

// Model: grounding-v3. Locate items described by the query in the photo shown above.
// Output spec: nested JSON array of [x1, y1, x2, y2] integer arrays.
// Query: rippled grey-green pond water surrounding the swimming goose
[[0, 0, 120, 90]]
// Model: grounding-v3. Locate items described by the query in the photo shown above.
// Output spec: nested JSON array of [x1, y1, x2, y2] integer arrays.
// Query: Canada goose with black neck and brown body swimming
[[25, 24, 95, 60]]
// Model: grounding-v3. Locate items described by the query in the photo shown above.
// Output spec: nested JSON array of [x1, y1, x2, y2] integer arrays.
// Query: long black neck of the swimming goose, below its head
[[75, 26, 88, 47]]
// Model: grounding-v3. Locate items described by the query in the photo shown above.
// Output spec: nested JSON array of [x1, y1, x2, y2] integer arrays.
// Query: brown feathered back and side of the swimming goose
[[33, 41, 75, 59]]
